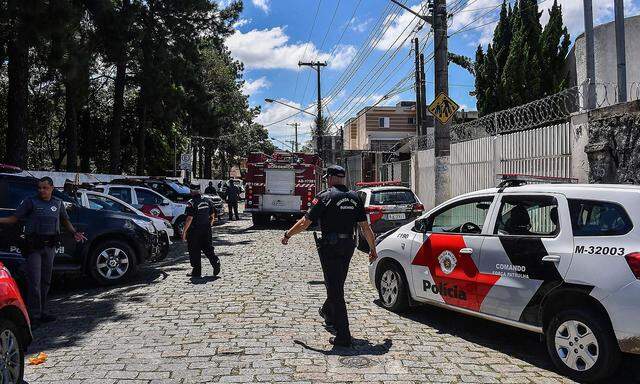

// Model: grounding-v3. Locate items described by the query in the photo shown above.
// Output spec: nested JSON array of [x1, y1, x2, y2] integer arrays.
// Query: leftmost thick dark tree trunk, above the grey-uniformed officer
[[5, 0, 31, 168]]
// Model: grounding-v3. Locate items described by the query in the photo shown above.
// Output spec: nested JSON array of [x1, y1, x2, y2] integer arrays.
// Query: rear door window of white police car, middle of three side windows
[[494, 196, 560, 236]]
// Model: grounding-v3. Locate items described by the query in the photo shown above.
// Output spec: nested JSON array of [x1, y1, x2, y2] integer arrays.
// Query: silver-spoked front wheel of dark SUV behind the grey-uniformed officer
[[89, 240, 136, 285]]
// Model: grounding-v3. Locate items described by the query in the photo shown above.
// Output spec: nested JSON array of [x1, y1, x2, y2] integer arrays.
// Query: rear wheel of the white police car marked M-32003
[[545, 309, 621, 382]]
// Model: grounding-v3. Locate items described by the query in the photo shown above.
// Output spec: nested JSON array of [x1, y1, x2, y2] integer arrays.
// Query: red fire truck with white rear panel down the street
[[244, 152, 322, 225]]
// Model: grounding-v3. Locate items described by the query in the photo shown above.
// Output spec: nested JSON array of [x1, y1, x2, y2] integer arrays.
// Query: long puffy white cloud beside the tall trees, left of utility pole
[[226, 27, 356, 70]]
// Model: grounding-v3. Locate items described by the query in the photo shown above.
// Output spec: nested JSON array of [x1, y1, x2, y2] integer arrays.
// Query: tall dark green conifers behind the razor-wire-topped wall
[[474, 0, 570, 115]]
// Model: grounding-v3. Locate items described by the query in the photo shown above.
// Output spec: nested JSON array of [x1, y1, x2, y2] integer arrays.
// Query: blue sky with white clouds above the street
[[222, 0, 640, 147]]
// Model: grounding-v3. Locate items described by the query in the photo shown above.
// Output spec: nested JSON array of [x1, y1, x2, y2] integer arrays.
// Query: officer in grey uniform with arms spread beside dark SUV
[[0, 177, 87, 324]]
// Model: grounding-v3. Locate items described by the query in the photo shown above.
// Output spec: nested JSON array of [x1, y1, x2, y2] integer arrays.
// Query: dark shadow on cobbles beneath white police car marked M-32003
[[388, 300, 640, 383]]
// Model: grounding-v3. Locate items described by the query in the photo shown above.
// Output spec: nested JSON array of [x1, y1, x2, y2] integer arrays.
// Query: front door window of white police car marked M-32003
[[428, 196, 493, 233]]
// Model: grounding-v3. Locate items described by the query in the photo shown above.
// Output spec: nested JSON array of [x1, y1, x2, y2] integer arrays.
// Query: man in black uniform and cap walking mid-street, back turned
[[282, 165, 378, 347]]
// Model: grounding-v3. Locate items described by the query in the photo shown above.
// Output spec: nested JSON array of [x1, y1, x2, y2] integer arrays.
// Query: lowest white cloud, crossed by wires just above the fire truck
[[256, 99, 315, 141]]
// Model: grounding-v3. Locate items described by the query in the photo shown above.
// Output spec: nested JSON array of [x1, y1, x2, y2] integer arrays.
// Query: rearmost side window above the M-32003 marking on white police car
[[569, 199, 633, 236]]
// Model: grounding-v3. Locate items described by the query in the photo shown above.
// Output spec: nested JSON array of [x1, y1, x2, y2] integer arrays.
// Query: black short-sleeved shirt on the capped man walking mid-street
[[305, 185, 367, 235]]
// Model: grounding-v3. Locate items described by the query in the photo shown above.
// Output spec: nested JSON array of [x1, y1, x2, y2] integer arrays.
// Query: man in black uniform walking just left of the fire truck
[[182, 184, 220, 278]]
